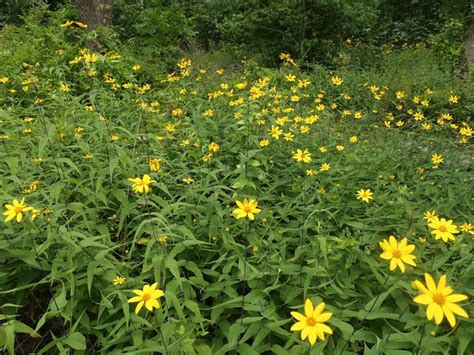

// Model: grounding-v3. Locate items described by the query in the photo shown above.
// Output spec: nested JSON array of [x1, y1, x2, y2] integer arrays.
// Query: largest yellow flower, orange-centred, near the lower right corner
[[413, 273, 468, 328]]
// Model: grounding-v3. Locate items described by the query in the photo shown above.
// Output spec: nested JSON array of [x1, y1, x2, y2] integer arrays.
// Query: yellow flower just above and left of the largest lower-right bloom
[[379, 235, 416, 272]]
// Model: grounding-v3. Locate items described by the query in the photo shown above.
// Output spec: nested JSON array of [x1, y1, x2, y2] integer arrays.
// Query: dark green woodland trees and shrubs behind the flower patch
[[0, 0, 474, 71]]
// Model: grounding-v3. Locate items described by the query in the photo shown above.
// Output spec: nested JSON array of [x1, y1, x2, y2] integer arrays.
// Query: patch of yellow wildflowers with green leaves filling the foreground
[[0, 9, 474, 354]]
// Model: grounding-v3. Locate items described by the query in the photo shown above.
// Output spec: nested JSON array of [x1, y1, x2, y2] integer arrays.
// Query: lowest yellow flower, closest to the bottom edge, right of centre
[[290, 298, 332, 345]]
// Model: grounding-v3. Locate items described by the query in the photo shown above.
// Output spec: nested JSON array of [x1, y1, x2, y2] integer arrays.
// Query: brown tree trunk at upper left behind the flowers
[[74, 0, 112, 31]]
